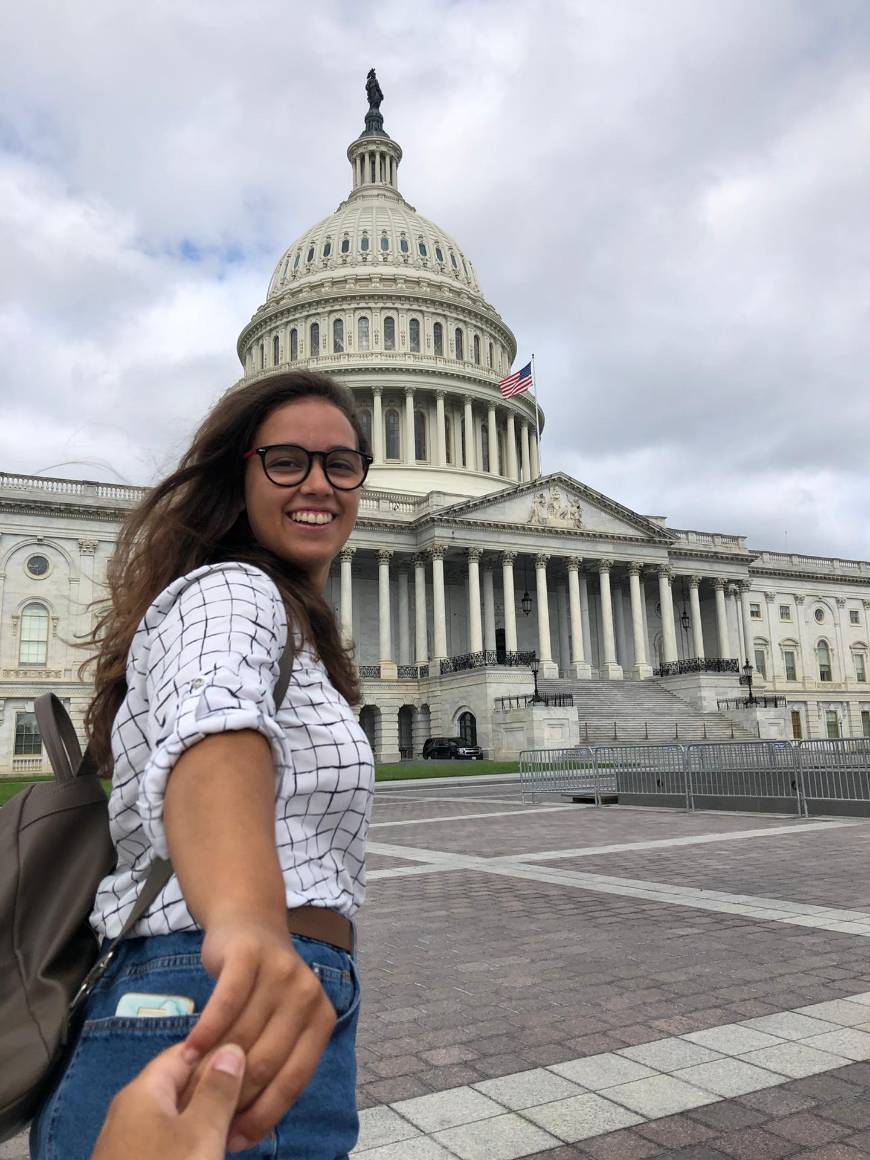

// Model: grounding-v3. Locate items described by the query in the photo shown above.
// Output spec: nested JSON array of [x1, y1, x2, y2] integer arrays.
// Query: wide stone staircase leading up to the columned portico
[[538, 679, 756, 745]]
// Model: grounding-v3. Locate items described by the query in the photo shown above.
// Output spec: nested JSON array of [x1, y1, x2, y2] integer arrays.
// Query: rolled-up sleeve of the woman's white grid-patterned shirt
[[138, 564, 288, 857]]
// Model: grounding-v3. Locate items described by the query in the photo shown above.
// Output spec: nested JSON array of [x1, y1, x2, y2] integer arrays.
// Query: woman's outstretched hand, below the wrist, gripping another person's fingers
[[184, 915, 335, 1152]]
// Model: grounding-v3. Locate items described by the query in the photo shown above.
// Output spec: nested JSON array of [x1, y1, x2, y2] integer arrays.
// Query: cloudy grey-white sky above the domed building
[[0, 0, 870, 559]]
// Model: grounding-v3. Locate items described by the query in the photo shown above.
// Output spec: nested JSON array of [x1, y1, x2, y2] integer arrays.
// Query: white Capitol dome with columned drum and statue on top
[[238, 71, 542, 495]]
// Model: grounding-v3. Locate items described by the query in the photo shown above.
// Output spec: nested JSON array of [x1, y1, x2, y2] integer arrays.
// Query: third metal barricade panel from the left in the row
[[686, 741, 804, 814]]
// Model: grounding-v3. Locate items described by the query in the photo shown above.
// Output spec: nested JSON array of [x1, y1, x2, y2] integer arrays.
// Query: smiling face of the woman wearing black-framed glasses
[[245, 398, 360, 592]]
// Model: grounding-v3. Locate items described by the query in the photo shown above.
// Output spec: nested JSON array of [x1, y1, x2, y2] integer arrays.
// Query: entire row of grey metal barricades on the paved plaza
[[520, 738, 870, 817]]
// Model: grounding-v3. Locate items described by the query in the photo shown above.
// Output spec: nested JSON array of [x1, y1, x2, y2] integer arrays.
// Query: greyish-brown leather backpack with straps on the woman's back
[[0, 633, 292, 1143]]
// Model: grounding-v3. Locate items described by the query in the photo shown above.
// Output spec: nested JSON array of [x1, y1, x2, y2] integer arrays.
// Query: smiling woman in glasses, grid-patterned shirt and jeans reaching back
[[31, 372, 374, 1160]]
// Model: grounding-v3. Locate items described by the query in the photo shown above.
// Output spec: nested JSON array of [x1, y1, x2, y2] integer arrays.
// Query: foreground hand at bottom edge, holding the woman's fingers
[[90, 1044, 245, 1160]]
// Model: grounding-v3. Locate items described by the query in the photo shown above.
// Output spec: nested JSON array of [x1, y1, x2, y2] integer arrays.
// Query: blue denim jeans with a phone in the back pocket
[[30, 934, 360, 1160]]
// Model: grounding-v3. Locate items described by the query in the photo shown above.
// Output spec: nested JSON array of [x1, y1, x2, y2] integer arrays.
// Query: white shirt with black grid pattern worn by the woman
[[90, 563, 375, 938]]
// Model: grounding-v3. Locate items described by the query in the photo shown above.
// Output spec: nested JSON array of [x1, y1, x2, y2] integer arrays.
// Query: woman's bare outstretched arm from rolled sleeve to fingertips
[[164, 730, 335, 1151]]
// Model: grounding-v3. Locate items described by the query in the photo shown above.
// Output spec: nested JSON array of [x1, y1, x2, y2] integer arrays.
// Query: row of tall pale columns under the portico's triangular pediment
[[340, 544, 753, 680]]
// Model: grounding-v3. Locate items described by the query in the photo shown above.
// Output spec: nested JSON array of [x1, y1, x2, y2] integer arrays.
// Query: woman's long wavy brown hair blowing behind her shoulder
[[80, 371, 369, 770]]
